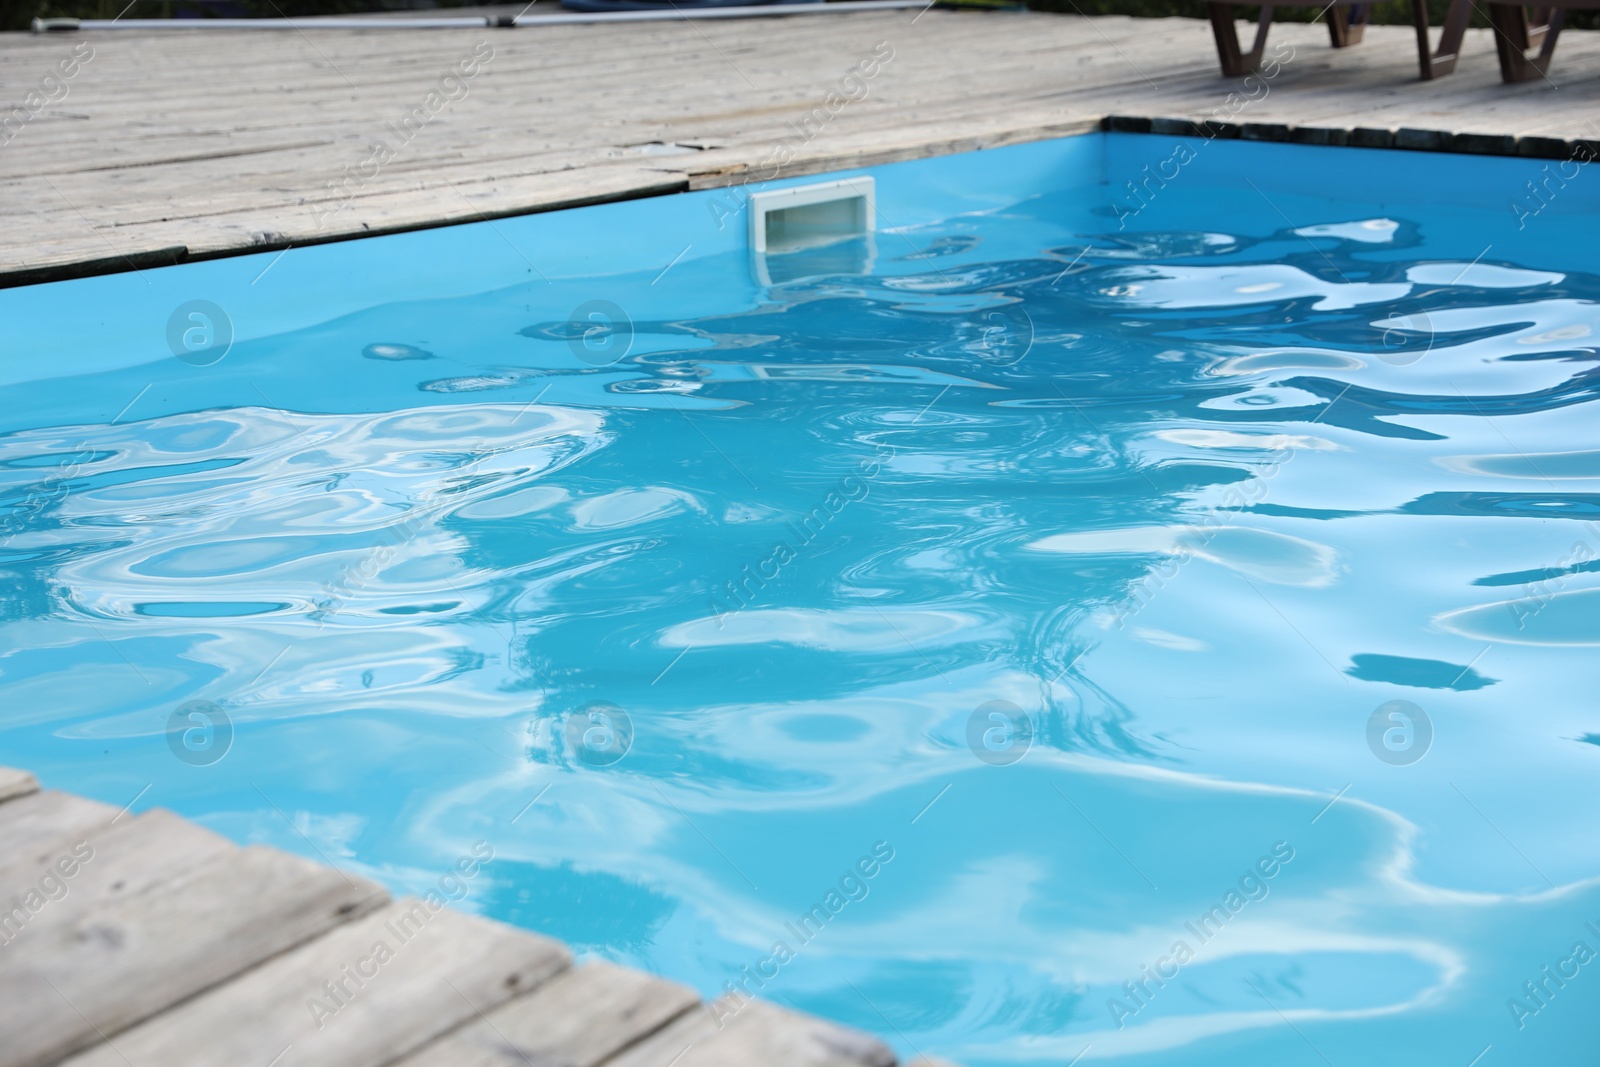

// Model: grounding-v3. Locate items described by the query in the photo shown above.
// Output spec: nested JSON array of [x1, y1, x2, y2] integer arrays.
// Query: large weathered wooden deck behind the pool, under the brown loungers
[[0, 5, 1600, 285]]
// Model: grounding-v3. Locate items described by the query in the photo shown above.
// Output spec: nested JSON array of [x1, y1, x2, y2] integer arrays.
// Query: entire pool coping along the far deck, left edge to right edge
[[12, 115, 1600, 290]]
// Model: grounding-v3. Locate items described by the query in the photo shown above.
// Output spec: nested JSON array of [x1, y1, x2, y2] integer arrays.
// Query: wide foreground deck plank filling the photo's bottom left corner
[[0, 846, 386, 1067]]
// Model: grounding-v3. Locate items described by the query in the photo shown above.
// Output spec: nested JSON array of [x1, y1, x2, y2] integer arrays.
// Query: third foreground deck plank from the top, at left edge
[[0, 811, 237, 947]]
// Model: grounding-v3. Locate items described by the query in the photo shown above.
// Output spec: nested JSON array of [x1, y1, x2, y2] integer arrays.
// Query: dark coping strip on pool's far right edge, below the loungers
[[1101, 115, 1600, 160]]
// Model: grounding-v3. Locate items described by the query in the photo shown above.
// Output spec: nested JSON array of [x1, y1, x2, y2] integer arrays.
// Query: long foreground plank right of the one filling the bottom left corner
[[67, 899, 571, 1067]]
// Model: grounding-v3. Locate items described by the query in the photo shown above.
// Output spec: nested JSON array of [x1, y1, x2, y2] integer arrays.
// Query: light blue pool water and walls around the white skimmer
[[0, 134, 1600, 1067]]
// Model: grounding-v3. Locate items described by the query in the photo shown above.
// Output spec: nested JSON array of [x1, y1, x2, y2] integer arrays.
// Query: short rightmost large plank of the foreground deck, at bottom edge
[[606, 998, 894, 1067]]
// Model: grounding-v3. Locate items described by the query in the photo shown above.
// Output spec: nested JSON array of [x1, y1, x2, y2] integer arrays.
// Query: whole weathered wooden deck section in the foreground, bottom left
[[0, 768, 933, 1067]]
